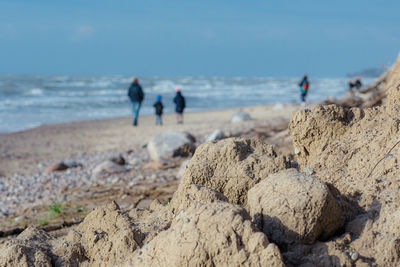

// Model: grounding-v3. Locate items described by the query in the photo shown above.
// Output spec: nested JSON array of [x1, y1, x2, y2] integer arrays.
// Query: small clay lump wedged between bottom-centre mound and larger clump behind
[[169, 184, 228, 214]]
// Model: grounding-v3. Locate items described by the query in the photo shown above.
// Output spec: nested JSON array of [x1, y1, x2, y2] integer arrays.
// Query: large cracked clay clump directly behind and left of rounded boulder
[[174, 138, 287, 204]]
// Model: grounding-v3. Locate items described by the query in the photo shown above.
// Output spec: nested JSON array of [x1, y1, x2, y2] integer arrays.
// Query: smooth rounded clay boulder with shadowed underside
[[248, 169, 344, 244]]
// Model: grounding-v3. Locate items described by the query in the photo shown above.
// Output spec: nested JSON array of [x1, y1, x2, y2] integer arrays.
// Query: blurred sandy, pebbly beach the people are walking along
[[0, 103, 301, 233]]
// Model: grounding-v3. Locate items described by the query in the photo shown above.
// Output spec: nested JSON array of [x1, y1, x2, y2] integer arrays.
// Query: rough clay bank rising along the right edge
[[290, 98, 400, 266]]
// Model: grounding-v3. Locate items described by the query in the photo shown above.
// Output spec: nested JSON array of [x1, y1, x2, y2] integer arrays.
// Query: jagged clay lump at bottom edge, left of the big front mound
[[66, 202, 145, 266]]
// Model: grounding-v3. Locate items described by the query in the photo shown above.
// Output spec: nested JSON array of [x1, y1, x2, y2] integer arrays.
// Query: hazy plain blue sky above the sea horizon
[[0, 0, 400, 77]]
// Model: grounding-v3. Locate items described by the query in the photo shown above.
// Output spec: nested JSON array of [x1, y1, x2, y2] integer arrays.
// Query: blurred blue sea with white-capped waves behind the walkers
[[0, 75, 374, 133]]
